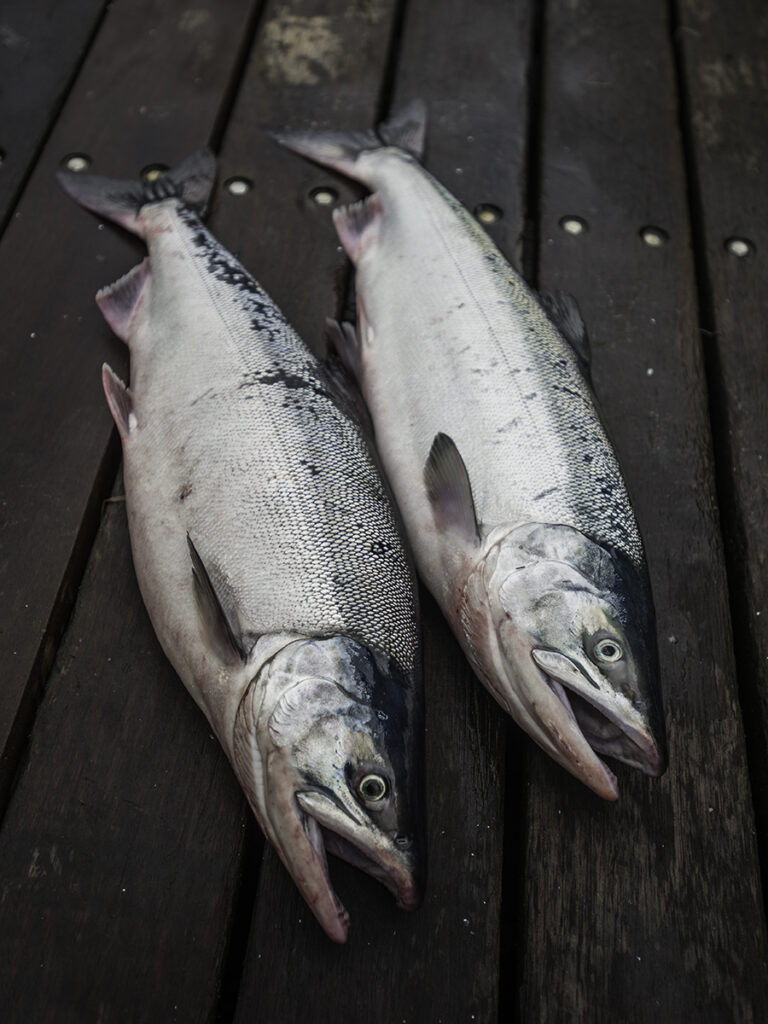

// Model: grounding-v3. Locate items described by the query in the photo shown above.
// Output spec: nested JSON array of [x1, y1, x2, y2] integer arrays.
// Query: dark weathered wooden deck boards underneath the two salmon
[[0, 0, 768, 1024]]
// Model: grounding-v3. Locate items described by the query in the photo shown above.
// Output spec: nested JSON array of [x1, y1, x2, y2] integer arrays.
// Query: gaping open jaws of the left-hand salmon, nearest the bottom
[[295, 790, 421, 942]]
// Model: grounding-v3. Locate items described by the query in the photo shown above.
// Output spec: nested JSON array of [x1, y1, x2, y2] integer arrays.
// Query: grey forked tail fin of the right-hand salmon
[[268, 99, 427, 184]]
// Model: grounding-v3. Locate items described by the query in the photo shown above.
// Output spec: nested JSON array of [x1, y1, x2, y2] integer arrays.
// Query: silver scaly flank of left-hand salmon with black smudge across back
[[132, 200, 416, 668]]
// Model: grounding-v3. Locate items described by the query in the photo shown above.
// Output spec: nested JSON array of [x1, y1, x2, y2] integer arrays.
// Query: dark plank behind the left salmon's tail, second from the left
[[0, 0, 260, 797]]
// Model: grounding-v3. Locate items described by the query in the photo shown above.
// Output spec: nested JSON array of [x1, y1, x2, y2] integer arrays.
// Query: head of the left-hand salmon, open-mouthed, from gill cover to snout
[[234, 637, 424, 942]]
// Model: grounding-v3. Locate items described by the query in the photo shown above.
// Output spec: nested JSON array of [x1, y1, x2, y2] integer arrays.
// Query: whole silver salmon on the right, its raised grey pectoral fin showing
[[274, 102, 666, 800]]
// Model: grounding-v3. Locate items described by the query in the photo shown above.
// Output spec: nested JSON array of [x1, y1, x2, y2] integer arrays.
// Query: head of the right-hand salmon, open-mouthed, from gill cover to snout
[[465, 523, 666, 800]]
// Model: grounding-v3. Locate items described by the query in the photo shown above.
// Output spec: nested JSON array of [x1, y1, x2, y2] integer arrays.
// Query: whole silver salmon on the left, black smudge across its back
[[59, 151, 423, 942]]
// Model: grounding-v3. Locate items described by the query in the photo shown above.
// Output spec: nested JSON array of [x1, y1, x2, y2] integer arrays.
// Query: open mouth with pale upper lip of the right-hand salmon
[[530, 648, 666, 782]]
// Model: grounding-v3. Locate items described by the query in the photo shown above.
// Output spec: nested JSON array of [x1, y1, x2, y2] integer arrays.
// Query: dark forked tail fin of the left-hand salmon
[[56, 148, 216, 236]]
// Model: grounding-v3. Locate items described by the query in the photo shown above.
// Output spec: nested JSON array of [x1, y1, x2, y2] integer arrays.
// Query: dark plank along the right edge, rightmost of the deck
[[677, 0, 768, 887]]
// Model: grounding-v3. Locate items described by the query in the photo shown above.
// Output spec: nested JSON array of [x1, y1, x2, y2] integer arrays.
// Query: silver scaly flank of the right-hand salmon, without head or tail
[[357, 162, 643, 566]]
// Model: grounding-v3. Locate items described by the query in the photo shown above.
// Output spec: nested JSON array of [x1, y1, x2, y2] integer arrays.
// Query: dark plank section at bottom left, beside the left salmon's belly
[[0, 482, 250, 1024]]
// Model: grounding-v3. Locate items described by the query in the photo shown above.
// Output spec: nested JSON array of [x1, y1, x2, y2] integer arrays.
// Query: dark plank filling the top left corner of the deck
[[0, 0, 105, 225]]
